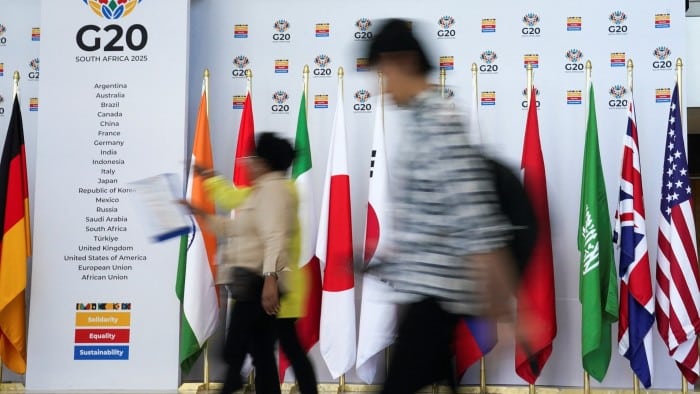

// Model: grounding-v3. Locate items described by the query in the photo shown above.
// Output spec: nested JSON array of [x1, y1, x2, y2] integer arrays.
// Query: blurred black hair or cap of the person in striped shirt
[[367, 19, 433, 75]]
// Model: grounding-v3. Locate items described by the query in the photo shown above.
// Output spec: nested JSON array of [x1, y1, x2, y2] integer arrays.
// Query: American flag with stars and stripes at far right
[[656, 84, 700, 383]]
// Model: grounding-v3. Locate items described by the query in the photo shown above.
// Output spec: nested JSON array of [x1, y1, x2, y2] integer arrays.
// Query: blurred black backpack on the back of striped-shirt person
[[486, 157, 537, 278]]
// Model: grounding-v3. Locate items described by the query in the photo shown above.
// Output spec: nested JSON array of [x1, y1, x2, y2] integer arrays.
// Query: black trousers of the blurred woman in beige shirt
[[221, 300, 280, 394]]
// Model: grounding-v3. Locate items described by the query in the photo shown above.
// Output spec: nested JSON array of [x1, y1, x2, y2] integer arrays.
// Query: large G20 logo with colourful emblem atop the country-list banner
[[75, 0, 148, 52]]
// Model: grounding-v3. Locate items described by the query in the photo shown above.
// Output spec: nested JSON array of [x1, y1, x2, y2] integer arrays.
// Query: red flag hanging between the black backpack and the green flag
[[515, 87, 557, 384]]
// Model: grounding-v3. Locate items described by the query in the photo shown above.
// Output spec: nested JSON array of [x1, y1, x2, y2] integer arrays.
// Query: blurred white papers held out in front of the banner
[[130, 174, 192, 242]]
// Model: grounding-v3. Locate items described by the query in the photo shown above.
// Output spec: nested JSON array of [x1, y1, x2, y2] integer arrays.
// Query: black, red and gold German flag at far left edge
[[0, 96, 31, 374]]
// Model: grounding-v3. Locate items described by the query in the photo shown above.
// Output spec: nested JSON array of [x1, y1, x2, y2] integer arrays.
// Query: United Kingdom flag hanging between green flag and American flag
[[613, 100, 654, 388]]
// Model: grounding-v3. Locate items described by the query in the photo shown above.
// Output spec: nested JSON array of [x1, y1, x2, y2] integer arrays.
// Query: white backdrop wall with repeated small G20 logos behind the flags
[[190, 0, 685, 388]]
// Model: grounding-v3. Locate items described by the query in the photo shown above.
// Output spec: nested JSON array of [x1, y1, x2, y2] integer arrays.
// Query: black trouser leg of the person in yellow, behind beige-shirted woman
[[277, 318, 318, 394]]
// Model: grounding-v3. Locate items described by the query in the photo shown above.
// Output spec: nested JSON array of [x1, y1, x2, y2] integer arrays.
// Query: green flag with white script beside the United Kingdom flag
[[578, 84, 618, 381]]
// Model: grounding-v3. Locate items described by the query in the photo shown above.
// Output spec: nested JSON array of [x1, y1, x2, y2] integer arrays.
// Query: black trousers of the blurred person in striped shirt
[[382, 299, 459, 394]]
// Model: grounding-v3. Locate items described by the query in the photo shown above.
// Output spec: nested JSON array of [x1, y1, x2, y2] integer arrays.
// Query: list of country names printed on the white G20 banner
[[63, 82, 148, 281]]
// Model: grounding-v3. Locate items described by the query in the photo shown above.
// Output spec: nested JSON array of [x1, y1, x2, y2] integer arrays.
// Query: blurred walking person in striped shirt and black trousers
[[367, 19, 514, 394]]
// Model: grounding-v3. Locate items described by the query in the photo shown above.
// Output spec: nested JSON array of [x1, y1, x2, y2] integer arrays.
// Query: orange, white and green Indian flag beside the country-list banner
[[175, 77, 219, 372]]
